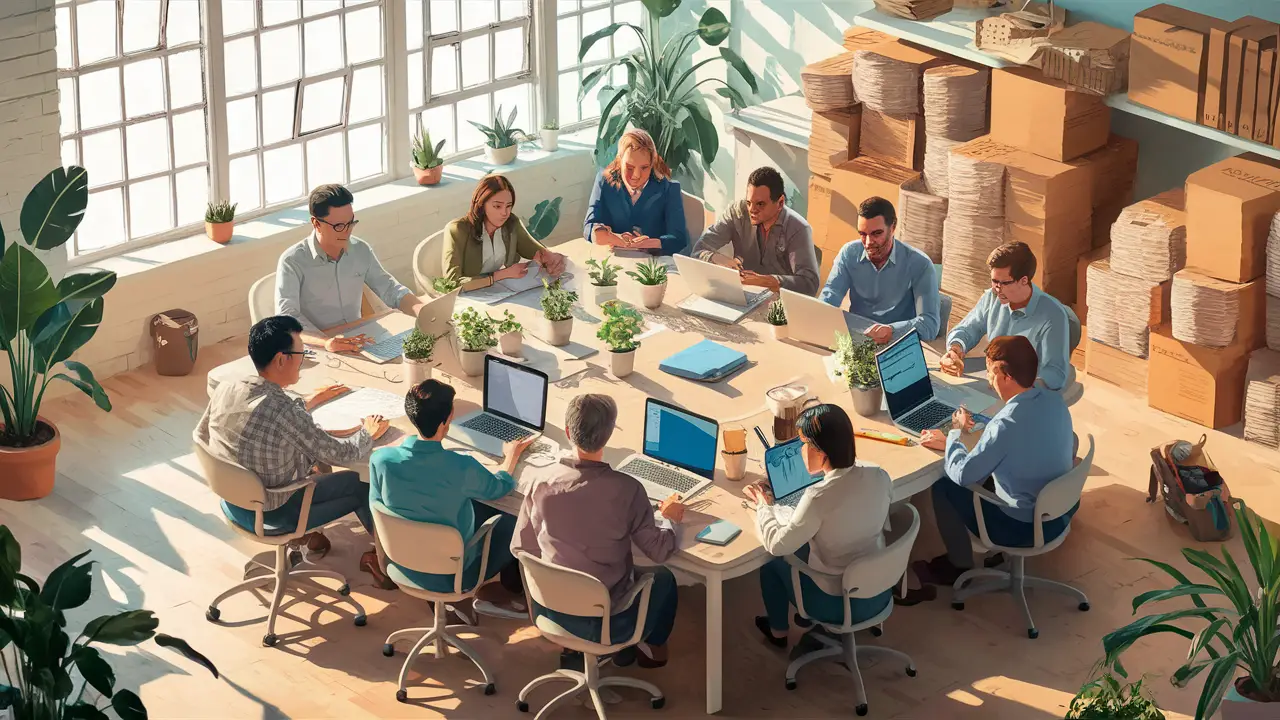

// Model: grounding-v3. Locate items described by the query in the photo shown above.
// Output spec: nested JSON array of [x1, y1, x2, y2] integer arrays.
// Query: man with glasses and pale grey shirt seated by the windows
[[275, 184, 422, 352]]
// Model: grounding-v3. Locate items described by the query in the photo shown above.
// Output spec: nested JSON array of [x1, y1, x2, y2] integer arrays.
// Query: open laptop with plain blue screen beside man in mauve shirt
[[618, 397, 719, 502]]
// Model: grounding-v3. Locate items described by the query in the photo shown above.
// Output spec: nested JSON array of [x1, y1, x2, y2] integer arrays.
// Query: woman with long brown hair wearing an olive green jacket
[[443, 176, 564, 290]]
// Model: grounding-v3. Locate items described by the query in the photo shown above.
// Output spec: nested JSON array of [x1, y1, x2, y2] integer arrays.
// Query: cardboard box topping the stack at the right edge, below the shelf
[[1187, 152, 1280, 282]]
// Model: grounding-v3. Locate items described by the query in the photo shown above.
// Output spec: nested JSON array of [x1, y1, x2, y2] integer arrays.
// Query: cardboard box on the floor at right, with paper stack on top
[[1147, 325, 1249, 428]]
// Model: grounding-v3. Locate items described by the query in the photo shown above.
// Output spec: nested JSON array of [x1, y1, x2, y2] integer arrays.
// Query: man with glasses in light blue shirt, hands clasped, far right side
[[941, 242, 1071, 391]]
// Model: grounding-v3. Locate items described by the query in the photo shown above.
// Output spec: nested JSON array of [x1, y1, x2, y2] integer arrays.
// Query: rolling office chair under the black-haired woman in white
[[786, 502, 920, 715]]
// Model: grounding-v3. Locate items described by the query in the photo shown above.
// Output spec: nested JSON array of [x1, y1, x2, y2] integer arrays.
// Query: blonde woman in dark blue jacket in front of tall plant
[[582, 128, 689, 255]]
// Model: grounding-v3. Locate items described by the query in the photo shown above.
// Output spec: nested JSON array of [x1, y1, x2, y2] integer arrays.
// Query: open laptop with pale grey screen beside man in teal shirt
[[448, 355, 548, 457]]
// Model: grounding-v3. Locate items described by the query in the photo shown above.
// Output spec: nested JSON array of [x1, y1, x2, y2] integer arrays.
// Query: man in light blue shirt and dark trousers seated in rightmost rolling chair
[[913, 336, 1079, 584]]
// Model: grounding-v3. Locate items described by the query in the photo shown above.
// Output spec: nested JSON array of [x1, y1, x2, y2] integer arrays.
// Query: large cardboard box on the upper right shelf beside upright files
[[1129, 4, 1228, 123]]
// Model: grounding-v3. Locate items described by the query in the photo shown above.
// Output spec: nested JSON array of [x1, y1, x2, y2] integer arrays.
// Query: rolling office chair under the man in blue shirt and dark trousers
[[951, 434, 1093, 639]]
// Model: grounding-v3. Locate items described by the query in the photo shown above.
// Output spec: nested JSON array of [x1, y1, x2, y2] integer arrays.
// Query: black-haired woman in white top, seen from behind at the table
[[745, 404, 893, 647]]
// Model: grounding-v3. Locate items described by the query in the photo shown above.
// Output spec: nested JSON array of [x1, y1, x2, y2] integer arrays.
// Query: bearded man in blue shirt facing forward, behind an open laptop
[[818, 197, 942, 345]]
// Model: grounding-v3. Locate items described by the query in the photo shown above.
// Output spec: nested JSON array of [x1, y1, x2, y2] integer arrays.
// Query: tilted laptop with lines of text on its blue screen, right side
[[876, 329, 956, 437]]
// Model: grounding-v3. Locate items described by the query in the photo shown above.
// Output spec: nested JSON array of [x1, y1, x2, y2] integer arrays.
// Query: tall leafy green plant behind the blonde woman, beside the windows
[[577, 0, 759, 170]]
